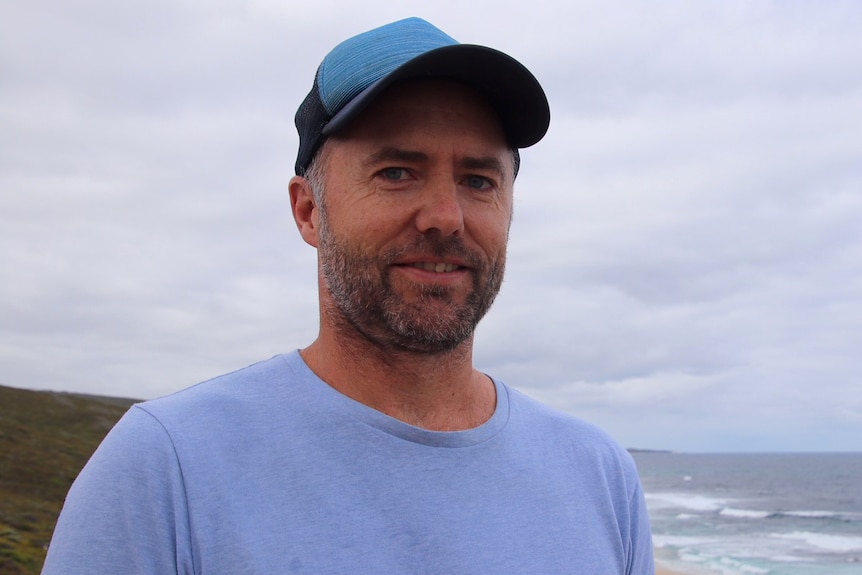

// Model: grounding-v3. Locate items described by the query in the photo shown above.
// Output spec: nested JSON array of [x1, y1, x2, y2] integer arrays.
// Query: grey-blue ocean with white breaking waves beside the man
[[633, 452, 862, 575]]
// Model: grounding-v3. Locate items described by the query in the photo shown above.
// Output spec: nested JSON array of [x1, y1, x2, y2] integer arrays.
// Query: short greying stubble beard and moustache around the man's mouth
[[319, 210, 506, 354]]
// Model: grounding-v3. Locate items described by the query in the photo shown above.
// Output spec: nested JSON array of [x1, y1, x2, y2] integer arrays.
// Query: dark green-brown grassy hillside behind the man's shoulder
[[0, 386, 134, 575]]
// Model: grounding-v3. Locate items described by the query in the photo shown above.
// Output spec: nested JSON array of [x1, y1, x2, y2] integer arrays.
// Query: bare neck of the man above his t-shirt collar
[[301, 330, 497, 431]]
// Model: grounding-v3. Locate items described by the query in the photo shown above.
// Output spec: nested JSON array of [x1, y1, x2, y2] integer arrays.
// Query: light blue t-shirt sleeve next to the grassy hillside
[[42, 407, 194, 575]]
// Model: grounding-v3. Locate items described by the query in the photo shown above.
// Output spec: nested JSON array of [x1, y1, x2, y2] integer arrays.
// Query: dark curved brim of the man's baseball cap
[[322, 44, 551, 148]]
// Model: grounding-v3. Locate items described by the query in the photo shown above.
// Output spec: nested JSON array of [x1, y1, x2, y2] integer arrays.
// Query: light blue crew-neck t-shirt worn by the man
[[43, 352, 653, 575]]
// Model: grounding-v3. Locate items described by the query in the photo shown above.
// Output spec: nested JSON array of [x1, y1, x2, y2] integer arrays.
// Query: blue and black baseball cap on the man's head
[[295, 18, 551, 175]]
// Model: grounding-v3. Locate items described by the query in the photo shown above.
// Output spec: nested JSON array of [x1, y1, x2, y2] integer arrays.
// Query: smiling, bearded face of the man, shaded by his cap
[[319, 82, 514, 353]]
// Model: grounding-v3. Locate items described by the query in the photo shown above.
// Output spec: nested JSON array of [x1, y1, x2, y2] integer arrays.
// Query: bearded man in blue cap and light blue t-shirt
[[45, 15, 653, 575]]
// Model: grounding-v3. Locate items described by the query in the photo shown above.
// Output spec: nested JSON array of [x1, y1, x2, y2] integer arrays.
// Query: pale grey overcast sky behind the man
[[0, 0, 862, 451]]
